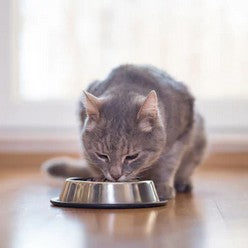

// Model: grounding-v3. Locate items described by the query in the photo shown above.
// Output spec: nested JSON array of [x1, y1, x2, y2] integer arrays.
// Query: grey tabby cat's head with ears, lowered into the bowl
[[82, 90, 166, 181]]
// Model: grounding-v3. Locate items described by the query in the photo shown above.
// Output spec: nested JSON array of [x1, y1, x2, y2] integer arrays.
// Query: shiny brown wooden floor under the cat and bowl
[[0, 160, 248, 248]]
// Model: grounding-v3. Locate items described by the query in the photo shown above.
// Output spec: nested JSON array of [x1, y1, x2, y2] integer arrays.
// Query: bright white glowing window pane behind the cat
[[16, 0, 248, 101]]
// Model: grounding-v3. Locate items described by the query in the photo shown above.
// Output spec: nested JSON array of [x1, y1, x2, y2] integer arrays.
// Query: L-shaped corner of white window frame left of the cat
[[0, 0, 78, 129]]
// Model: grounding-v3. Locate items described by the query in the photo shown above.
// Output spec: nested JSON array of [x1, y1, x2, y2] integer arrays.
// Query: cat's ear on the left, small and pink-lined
[[83, 91, 102, 121]]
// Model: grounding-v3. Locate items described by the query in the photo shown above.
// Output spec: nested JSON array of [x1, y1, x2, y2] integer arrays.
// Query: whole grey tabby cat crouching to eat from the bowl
[[43, 64, 206, 199]]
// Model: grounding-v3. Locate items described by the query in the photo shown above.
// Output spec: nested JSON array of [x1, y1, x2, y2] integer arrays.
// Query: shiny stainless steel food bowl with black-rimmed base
[[51, 177, 166, 208]]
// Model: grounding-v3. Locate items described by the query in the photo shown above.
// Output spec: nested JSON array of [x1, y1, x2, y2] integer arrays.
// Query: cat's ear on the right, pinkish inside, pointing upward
[[137, 90, 158, 132]]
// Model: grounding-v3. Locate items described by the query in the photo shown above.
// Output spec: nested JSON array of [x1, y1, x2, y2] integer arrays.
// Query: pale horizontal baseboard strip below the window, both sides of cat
[[0, 130, 248, 153]]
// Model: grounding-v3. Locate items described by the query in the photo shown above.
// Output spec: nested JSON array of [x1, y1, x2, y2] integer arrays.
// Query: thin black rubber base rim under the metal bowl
[[50, 197, 167, 208]]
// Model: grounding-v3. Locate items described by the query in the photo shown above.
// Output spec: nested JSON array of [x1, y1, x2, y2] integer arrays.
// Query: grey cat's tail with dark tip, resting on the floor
[[41, 157, 98, 184]]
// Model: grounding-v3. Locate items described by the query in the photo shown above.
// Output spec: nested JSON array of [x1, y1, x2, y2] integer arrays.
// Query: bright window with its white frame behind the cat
[[0, 0, 248, 151]]
